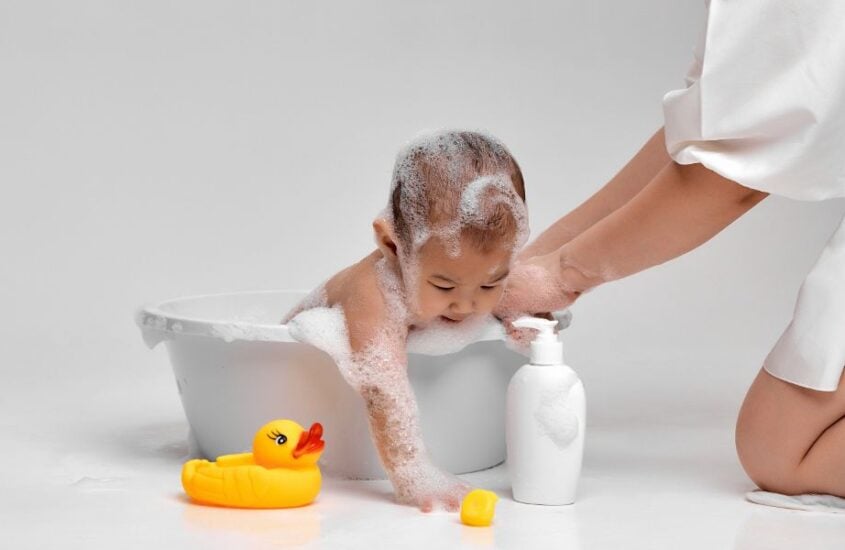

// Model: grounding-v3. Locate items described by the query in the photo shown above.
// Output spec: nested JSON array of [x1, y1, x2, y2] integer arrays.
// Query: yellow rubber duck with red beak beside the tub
[[182, 420, 325, 508]]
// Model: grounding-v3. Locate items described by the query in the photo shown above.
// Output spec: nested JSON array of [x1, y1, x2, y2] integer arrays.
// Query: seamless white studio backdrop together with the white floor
[[0, 0, 845, 550]]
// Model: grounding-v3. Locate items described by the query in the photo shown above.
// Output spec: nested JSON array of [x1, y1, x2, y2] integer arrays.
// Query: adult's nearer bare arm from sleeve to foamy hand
[[497, 162, 767, 319]]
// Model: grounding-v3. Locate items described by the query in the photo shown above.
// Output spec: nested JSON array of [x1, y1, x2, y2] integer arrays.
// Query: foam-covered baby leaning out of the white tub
[[283, 131, 528, 511]]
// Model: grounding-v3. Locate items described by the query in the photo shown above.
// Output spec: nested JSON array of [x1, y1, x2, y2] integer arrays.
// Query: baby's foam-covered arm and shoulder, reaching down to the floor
[[283, 255, 470, 511]]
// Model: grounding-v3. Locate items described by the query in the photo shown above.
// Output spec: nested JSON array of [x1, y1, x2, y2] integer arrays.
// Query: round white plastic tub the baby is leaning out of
[[136, 291, 525, 479]]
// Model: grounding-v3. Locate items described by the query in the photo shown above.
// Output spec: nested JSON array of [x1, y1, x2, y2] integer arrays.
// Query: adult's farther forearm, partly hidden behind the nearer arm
[[520, 128, 671, 258]]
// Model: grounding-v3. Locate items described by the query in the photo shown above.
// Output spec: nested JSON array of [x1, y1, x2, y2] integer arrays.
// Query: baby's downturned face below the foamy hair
[[408, 237, 511, 323]]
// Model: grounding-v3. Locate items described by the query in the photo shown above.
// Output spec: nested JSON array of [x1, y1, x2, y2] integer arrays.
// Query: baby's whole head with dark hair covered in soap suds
[[373, 131, 528, 323]]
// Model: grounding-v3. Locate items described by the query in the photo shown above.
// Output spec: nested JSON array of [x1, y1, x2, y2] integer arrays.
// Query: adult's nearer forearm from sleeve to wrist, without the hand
[[558, 162, 767, 292]]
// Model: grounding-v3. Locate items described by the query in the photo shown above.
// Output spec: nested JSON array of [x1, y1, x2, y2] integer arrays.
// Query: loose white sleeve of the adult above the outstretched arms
[[663, 0, 845, 200]]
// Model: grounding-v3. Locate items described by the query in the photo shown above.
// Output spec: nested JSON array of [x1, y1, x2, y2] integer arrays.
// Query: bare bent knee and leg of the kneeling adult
[[736, 369, 845, 498]]
